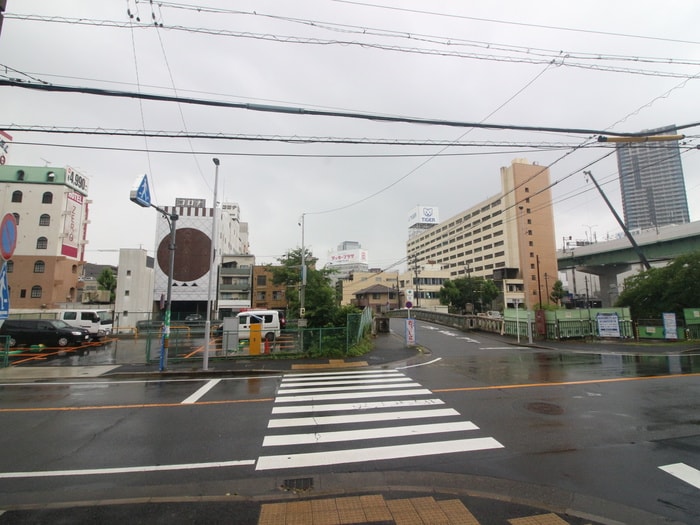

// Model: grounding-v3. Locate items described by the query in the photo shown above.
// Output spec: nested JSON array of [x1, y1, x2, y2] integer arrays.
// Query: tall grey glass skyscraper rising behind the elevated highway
[[616, 128, 690, 230]]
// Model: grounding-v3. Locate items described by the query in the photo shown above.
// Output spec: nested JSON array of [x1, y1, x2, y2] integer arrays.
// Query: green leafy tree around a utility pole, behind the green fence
[[270, 248, 338, 328]]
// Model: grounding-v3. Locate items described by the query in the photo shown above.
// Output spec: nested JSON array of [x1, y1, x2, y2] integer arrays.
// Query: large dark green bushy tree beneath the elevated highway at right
[[615, 252, 700, 319]]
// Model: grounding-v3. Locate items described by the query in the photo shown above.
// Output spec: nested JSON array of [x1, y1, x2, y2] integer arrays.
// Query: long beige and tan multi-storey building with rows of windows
[[406, 159, 557, 309]]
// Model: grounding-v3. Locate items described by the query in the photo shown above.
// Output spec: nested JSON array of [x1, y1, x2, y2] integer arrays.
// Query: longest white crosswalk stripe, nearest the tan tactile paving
[[255, 437, 503, 470]]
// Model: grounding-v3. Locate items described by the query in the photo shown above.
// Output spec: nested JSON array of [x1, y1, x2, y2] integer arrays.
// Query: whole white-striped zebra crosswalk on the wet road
[[256, 370, 503, 470]]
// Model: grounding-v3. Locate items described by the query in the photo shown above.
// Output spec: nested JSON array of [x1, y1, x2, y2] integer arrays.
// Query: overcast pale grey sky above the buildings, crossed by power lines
[[0, 0, 700, 268]]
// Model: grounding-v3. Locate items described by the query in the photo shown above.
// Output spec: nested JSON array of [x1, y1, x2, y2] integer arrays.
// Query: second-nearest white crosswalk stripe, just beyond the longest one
[[263, 421, 479, 447]]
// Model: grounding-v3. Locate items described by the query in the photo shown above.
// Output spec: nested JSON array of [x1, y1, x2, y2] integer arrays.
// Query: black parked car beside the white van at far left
[[0, 319, 90, 346]]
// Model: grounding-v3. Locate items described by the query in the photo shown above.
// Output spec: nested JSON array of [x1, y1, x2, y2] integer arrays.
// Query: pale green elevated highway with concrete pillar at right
[[557, 221, 700, 306]]
